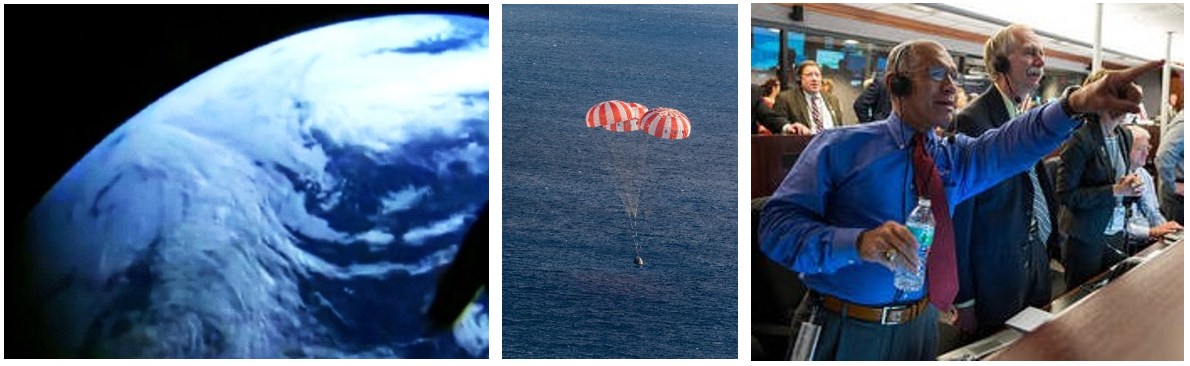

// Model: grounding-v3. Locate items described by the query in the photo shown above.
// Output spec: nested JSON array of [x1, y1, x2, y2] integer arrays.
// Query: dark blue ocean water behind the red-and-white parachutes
[[501, 5, 739, 359]]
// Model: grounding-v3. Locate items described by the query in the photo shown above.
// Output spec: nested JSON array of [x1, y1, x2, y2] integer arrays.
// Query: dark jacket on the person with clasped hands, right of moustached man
[[1058, 122, 1132, 242]]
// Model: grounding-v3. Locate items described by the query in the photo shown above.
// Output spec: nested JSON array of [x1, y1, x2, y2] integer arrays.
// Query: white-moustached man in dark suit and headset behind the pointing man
[[954, 25, 1061, 340]]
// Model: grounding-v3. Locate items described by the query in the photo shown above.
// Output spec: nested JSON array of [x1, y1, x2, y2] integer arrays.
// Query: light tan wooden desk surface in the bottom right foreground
[[988, 242, 1185, 360]]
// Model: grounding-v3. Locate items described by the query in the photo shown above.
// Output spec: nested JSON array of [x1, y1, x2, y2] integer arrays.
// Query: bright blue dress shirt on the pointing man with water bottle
[[759, 102, 1081, 305]]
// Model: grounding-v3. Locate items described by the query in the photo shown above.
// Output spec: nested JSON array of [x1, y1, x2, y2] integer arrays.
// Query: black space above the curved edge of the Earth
[[4, 5, 488, 358]]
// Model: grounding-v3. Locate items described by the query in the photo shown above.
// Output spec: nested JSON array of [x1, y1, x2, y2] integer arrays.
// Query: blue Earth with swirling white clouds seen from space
[[10, 14, 489, 358]]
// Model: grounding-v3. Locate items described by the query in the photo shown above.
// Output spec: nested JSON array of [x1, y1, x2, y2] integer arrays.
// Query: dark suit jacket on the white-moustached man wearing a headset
[[952, 86, 1061, 334]]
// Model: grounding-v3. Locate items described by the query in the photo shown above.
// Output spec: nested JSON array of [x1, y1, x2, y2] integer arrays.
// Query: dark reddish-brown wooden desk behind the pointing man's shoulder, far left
[[752, 134, 814, 198]]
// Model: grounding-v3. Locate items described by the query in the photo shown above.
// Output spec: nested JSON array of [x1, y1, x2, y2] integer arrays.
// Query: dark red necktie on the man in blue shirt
[[912, 133, 959, 311]]
